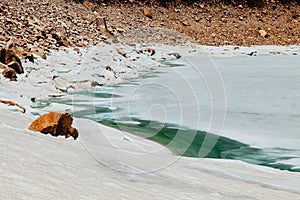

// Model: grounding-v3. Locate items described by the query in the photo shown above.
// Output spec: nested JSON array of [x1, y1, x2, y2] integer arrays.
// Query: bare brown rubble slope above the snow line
[[0, 0, 300, 54]]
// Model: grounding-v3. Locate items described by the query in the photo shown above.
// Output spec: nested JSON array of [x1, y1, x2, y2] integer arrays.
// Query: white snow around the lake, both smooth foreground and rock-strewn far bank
[[0, 44, 300, 200]]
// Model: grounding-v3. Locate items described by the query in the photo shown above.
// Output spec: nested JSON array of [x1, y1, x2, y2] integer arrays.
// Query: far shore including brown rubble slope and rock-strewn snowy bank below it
[[0, 0, 300, 103]]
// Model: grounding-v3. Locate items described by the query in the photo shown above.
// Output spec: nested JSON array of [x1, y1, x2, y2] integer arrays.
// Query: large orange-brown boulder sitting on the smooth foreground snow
[[28, 112, 78, 140]]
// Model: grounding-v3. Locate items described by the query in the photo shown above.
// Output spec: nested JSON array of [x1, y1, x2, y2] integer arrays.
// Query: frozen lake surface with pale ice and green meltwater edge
[[37, 55, 300, 172]]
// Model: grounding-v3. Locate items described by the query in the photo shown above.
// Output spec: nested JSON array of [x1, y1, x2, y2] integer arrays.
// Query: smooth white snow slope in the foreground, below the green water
[[0, 109, 300, 200]]
